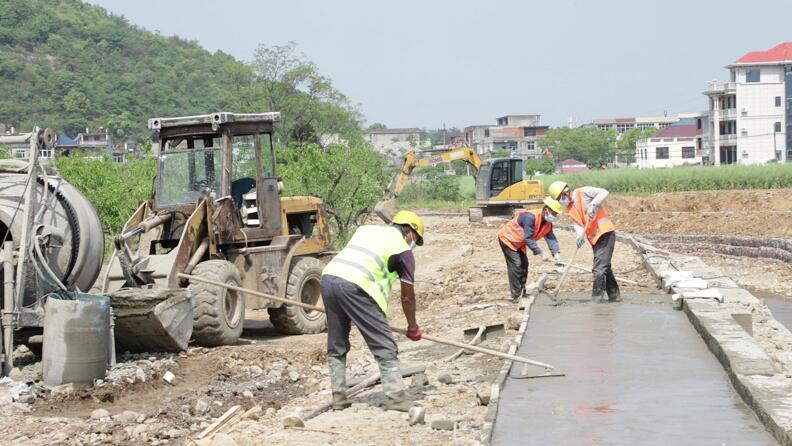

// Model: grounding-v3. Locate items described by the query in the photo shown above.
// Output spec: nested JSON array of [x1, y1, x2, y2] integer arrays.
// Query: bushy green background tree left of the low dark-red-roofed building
[[539, 127, 616, 167]]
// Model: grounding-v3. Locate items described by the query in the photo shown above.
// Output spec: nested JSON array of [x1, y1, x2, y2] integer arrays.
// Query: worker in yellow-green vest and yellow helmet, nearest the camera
[[322, 211, 424, 412]]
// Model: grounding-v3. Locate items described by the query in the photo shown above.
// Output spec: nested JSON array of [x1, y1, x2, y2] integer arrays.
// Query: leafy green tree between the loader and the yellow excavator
[[279, 137, 390, 243]]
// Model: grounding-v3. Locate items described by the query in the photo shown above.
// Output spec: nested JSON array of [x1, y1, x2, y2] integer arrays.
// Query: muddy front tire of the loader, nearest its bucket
[[190, 260, 245, 347]]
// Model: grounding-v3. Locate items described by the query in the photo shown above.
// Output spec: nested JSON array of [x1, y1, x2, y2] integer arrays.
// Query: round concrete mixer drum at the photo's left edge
[[0, 172, 104, 305]]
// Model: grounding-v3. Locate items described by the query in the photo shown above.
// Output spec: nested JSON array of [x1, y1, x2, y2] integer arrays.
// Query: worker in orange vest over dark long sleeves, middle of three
[[498, 197, 561, 302]]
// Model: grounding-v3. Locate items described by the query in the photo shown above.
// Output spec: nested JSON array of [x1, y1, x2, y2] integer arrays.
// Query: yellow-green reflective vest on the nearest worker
[[322, 225, 410, 316]]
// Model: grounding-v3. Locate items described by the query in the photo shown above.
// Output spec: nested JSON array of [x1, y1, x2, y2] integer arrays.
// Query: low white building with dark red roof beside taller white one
[[635, 124, 701, 169]]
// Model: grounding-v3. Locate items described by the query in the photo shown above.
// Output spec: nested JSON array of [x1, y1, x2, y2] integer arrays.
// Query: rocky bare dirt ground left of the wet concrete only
[[0, 217, 652, 445]]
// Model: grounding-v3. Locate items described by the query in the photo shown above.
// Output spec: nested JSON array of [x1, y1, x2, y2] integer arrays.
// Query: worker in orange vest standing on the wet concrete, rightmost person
[[548, 181, 621, 302]]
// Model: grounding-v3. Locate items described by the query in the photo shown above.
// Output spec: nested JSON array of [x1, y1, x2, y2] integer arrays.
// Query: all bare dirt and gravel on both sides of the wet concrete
[[0, 190, 792, 445]]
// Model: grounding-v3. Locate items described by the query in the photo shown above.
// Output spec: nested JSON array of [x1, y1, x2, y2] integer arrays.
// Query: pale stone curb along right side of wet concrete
[[634, 253, 792, 446]]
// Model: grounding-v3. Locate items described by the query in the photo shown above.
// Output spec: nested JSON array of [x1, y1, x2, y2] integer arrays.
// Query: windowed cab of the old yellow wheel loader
[[149, 113, 281, 236]]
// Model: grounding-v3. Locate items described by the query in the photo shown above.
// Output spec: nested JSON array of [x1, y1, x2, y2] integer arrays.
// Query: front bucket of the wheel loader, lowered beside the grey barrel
[[109, 288, 193, 353]]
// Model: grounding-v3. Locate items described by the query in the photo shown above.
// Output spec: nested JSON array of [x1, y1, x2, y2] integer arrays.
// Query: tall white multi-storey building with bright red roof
[[699, 42, 792, 165]]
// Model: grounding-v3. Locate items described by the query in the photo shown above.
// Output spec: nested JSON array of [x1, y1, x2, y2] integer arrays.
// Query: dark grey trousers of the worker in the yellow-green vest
[[322, 276, 399, 361]]
